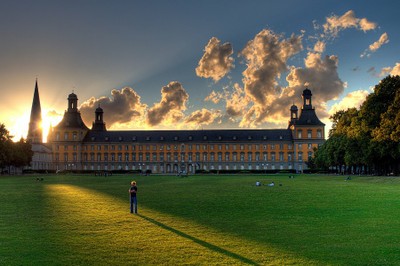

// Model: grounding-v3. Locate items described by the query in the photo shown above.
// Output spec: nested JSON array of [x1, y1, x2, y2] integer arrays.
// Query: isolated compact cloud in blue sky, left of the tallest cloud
[[196, 37, 234, 82]]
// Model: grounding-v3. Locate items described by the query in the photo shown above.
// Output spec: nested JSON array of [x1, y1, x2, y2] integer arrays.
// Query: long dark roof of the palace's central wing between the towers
[[83, 129, 292, 143]]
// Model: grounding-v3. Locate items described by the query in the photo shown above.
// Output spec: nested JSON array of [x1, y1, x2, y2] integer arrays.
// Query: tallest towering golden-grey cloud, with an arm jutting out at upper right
[[240, 29, 303, 106]]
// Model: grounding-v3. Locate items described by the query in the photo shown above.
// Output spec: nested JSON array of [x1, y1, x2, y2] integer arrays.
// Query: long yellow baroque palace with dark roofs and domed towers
[[26, 81, 325, 173]]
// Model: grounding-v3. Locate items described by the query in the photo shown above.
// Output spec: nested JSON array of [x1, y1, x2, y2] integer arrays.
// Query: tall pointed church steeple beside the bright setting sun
[[27, 79, 43, 143]]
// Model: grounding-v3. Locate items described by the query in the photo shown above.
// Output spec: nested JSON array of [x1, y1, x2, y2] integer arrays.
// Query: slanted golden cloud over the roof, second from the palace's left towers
[[146, 81, 189, 126]]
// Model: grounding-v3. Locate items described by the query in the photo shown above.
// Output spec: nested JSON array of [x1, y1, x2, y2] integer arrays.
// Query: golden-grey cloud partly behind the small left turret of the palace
[[80, 87, 146, 128]]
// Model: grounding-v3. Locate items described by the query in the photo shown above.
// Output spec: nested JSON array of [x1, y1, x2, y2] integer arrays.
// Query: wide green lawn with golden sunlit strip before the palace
[[0, 175, 400, 265]]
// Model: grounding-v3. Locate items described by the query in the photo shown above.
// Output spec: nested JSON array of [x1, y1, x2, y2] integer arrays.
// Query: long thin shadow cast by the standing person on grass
[[138, 214, 259, 265]]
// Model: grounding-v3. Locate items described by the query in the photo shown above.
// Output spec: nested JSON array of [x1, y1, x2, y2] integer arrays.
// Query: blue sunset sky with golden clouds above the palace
[[0, 0, 400, 141]]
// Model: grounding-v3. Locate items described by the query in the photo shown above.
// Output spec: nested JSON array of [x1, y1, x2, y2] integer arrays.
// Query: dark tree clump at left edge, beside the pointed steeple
[[0, 124, 33, 173]]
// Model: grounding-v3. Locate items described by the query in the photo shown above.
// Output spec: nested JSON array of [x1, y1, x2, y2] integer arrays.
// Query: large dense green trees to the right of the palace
[[310, 76, 400, 175]]
